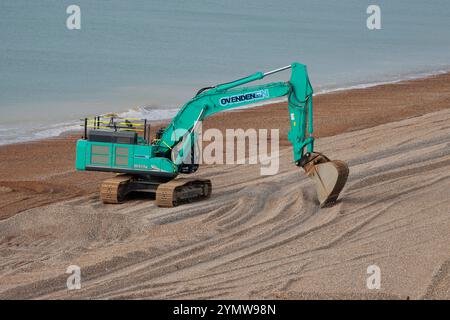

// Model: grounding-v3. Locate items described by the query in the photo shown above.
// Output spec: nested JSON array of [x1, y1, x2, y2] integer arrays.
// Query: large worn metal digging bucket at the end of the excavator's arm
[[303, 153, 349, 207]]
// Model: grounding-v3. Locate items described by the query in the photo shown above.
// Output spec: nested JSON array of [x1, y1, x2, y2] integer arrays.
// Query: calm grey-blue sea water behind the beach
[[0, 0, 450, 144]]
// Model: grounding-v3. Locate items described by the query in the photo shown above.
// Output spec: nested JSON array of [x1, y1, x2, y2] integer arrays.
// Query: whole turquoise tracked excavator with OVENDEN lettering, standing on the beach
[[76, 63, 349, 207]]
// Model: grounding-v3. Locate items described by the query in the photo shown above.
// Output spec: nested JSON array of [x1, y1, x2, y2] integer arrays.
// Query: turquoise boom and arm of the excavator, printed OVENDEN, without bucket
[[158, 63, 314, 162]]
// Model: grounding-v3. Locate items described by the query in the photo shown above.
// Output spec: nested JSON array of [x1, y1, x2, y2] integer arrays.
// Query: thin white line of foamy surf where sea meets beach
[[0, 69, 450, 148]]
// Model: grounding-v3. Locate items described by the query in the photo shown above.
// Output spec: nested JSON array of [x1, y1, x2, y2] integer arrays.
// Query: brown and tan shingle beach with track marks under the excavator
[[0, 74, 450, 299]]
